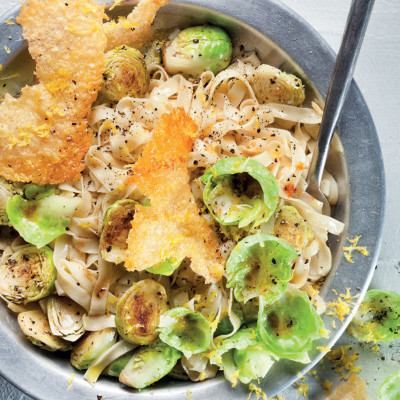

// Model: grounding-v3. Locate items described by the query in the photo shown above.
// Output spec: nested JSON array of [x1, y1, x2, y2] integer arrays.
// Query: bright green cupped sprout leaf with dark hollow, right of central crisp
[[201, 157, 279, 228]]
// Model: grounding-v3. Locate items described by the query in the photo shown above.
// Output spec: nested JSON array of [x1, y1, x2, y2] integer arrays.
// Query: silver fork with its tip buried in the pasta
[[307, 0, 375, 215]]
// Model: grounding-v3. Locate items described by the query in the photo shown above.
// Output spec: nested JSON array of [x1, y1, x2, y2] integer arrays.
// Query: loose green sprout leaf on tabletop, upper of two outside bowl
[[349, 289, 400, 342]]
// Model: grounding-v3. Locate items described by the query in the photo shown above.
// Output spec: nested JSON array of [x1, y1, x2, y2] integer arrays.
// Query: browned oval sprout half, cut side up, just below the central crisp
[[115, 279, 168, 344]]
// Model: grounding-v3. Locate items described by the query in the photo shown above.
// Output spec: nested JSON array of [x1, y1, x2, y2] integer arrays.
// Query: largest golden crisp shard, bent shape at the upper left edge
[[0, 0, 106, 184]]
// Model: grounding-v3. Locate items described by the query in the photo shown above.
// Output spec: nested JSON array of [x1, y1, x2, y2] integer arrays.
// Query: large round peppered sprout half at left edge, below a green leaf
[[0, 245, 57, 304]]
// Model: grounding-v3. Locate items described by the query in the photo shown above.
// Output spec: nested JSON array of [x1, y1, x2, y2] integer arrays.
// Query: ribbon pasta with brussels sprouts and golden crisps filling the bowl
[[0, 0, 343, 389]]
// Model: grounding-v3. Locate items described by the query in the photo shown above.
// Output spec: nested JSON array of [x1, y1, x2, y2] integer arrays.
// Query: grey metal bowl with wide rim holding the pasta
[[0, 0, 385, 400]]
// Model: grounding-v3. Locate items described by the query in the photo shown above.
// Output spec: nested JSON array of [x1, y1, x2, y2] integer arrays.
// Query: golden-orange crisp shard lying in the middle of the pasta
[[125, 108, 224, 282]]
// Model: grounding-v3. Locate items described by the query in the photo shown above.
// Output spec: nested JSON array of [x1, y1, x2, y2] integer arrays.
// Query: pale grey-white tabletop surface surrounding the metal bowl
[[0, 0, 400, 400]]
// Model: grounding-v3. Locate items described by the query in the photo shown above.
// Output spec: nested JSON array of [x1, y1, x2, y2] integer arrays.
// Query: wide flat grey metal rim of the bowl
[[0, 0, 385, 400]]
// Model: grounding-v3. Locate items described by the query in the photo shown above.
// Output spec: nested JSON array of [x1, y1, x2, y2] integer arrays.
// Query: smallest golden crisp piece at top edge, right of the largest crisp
[[104, 0, 169, 51]]
